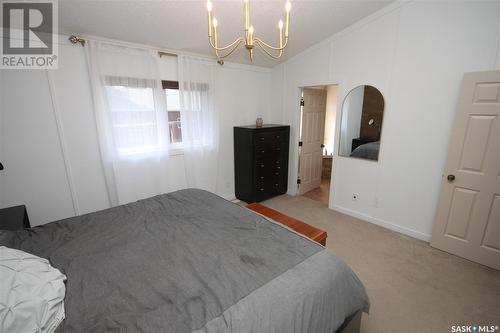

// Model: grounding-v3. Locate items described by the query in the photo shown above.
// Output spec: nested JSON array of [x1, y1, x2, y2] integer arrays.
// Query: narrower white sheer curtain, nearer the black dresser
[[178, 56, 219, 192]]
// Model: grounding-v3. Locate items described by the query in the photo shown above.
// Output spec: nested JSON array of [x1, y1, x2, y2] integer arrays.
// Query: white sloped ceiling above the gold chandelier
[[59, 0, 392, 67]]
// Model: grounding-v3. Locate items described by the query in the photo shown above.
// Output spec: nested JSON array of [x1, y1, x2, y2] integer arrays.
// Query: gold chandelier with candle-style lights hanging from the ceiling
[[207, 0, 292, 61]]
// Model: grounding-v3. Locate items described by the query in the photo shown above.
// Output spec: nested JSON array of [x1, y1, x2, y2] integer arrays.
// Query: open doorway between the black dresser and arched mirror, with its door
[[297, 85, 338, 206]]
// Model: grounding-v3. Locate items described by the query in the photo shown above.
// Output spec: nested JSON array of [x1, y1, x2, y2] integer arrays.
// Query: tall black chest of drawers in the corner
[[234, 125, 290, 202]]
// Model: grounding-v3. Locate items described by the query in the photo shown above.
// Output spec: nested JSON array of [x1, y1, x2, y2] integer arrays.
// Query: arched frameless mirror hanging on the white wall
[[339, 85, 385, 161]]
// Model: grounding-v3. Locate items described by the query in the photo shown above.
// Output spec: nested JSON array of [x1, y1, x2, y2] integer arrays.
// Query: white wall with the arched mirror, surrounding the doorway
[[272, 1, 500, 240]]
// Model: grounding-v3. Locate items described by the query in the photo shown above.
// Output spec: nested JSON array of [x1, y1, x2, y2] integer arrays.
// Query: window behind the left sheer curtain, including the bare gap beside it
[[104, 76, 182, 157]]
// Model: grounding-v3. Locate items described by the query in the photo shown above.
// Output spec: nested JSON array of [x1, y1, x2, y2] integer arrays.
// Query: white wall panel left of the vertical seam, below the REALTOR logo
[[0, 70, 77, 221]]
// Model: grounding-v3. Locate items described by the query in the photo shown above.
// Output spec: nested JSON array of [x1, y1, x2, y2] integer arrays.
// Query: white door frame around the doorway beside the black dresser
[[294, 83, 344, 200]]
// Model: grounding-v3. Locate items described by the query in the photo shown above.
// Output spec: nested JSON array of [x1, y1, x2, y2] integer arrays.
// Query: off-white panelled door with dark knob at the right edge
[[431, 71, 500, 269]]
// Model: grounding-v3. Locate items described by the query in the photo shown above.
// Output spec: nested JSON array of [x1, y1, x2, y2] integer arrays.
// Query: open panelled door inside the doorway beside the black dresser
[[299, 88, 326, 194]]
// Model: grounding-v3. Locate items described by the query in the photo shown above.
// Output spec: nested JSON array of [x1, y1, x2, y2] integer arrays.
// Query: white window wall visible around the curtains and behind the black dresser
[[0, 36, 272, 225]]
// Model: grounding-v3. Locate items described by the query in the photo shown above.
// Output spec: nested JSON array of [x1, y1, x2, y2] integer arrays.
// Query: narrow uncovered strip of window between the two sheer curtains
[[161, 80, 182, 148]]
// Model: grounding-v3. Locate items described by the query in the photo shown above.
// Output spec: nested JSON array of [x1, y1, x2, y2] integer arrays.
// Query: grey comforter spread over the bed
[[0, 189, 369, 333]]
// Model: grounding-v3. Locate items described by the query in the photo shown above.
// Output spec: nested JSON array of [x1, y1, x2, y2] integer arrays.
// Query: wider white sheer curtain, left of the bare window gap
[[85, 41, 169, 206]]
